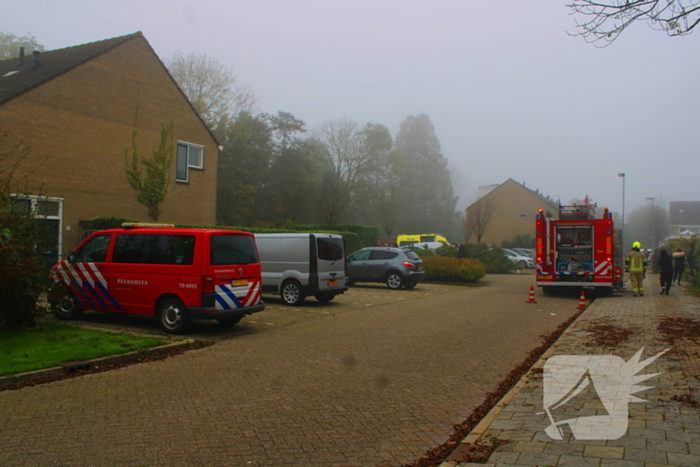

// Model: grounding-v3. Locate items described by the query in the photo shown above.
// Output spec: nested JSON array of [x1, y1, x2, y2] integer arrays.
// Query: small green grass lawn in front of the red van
[[0, 321, 166, 376]]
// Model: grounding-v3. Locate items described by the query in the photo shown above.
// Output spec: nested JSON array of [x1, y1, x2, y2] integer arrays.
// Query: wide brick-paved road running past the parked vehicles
[[0, 274, 578, 467]]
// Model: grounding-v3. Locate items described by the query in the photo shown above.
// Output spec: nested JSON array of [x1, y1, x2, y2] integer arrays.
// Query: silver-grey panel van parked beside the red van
[[255, 233, 348, 305]]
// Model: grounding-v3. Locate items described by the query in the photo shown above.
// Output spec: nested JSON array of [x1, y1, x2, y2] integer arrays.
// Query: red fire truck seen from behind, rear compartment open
[[535, 204, 623, 293]]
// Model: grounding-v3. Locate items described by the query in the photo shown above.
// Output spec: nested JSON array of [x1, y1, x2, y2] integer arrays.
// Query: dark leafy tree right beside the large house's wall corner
[[216, 112, 273, 226]]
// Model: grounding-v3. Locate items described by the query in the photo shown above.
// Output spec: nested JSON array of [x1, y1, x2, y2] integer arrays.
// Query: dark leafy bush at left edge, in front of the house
[[0, 132, 51, 330]]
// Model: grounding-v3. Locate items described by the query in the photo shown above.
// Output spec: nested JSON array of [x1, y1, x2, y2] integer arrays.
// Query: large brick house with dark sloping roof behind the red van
[[0, 32, 218, 256]]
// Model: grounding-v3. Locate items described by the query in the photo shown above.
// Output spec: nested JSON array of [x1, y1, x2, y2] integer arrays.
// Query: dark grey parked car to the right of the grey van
[[347, 247, 425, 290]]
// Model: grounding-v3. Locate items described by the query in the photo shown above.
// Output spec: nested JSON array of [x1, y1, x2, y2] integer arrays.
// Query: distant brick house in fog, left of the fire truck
[[466, 178, 559, 245]]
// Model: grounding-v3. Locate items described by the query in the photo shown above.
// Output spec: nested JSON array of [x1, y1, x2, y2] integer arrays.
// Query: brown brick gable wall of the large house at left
[[0, 37, 217, 254]]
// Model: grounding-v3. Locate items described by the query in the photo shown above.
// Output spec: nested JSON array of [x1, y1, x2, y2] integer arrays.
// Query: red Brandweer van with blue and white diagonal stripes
[[51, 224, 265, 334]]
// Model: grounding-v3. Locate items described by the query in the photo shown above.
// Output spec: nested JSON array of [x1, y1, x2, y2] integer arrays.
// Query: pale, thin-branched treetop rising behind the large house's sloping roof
[[166, 51, 258, 130]]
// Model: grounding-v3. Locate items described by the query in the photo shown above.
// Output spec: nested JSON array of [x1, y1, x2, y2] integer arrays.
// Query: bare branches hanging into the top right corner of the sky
[[566, 0, 700, 47]]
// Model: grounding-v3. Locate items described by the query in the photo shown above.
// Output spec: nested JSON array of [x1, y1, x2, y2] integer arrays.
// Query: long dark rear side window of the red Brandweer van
[[112, 234, 194, 265]]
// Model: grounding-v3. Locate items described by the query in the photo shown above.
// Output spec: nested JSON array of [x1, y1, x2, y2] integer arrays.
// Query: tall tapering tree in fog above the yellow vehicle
[[395, 114, 457, 233]]
